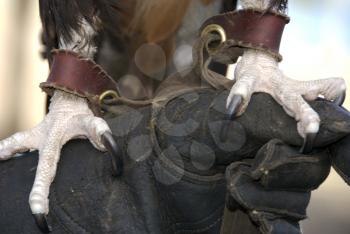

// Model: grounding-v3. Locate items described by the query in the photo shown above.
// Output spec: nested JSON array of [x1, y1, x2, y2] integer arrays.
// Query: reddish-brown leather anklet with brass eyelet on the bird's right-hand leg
[[201, 9, 289, 61]]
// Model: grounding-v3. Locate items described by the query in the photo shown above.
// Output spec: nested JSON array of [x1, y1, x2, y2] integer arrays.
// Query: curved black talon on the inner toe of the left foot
[[102, 132, 123, 176]]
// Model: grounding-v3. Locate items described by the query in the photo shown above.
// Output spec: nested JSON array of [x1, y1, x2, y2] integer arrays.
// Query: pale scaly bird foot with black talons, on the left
[[0, 91, 122, 232]]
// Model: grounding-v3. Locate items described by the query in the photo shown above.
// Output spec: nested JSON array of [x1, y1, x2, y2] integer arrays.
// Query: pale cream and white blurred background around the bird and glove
[[0, 0, 350, 234]]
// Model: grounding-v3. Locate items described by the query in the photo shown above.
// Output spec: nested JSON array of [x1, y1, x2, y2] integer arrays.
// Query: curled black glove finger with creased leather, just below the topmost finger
[[251, 139, 330, 191]]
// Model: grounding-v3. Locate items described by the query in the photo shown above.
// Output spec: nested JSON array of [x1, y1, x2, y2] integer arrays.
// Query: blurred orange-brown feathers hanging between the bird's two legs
[[109, 0, 191, 66]]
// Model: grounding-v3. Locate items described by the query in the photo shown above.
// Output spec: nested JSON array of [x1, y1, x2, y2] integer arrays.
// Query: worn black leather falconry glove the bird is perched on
[[0, 89, 350, 234]]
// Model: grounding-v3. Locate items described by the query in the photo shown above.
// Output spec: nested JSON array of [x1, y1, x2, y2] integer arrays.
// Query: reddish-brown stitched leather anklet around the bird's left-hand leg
[[40, 50, 118, 113]]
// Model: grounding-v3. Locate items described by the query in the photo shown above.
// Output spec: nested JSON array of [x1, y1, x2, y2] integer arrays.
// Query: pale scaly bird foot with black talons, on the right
[[226, 49, 346, 153]]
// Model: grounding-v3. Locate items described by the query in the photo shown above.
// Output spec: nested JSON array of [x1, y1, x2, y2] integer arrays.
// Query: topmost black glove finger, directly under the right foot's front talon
[[237, 94, 350, 147]]
